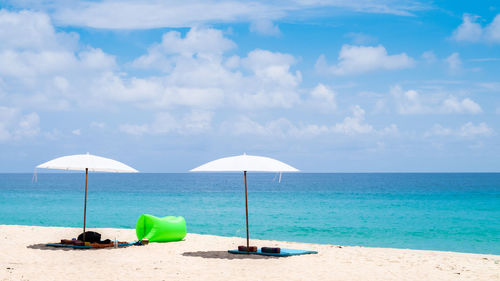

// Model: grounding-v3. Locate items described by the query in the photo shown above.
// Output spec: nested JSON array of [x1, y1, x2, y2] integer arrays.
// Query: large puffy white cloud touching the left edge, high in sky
[[0, 10, 117, 110]]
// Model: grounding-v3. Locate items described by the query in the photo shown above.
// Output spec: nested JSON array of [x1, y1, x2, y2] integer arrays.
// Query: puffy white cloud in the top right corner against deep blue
[[452, 14, 500, 43]]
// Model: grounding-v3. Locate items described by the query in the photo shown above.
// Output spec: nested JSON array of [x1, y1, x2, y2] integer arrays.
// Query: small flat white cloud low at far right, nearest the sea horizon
[[424, 122, 494, 138]]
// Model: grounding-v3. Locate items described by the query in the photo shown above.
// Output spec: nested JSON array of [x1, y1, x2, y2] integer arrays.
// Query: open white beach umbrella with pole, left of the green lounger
[[36, 153, 138, 237]]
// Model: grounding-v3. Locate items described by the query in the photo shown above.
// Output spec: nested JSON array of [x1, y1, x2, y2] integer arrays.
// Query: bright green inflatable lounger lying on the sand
[[135, 214, 186, 242]]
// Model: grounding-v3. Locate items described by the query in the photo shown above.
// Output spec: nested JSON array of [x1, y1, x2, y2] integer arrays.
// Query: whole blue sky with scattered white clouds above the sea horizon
[[0, 0, 500, 172]]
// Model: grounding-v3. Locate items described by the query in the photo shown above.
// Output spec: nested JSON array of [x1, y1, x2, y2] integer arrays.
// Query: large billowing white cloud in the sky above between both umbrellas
[[131, 28, 302, 108]]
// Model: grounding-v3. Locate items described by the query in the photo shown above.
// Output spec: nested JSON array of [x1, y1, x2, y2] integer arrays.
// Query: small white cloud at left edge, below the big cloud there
[[0, 106, 40, 141]]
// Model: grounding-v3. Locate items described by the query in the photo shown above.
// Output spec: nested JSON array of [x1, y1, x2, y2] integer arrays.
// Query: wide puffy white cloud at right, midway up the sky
[[391, 86, 483, 115]]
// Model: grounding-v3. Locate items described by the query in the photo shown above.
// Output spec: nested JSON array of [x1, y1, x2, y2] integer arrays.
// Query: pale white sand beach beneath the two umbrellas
[[0, 225, 500, 280]]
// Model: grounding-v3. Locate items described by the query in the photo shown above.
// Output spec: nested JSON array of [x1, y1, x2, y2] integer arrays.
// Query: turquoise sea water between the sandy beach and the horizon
[[0, 173, 500, 254]]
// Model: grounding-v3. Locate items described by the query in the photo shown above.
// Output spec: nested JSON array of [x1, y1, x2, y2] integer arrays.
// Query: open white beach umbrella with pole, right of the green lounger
[[191, 154, 299, 250]]
